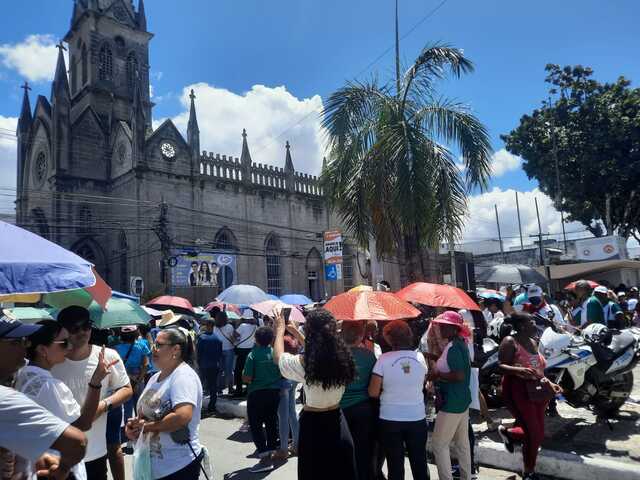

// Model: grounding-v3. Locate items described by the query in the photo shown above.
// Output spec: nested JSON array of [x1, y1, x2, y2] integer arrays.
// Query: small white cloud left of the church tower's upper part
[[0, 35, 64, 82]]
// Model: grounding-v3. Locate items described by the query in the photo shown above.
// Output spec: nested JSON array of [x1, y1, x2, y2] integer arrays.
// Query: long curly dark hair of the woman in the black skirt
[[304, 308, 355, 390]]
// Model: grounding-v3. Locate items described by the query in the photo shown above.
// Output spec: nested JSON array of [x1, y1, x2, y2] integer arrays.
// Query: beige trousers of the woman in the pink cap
[[432, 409, 471, 480]]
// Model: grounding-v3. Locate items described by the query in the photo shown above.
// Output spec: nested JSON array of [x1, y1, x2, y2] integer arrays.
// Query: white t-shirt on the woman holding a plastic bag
[[138, 363, 202, 478]]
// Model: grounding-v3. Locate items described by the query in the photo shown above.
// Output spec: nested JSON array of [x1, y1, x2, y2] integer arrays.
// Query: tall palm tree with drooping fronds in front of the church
[[322, 34, 492, 281]]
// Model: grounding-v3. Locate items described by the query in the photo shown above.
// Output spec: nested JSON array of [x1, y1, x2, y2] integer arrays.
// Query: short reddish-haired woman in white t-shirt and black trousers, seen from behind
[[369, 320, 429, 480]]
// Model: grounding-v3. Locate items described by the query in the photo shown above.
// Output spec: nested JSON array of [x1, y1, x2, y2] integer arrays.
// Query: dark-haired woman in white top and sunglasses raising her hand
[[15, 320, 112, 480]]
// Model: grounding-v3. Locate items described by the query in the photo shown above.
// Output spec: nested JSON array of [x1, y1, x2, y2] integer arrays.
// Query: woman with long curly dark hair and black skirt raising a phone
[[273, 309, 358, 480]]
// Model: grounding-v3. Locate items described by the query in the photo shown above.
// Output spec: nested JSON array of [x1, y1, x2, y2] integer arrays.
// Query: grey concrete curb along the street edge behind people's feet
[[208, 398, 639, 480]]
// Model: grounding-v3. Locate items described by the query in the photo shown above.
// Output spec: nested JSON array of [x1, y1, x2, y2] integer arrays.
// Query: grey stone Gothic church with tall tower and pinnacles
[[16, 0, 399, 303]]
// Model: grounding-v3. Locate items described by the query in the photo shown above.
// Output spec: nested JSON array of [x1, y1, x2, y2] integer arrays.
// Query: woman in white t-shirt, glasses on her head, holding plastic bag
[[125, 328, 205, 480]]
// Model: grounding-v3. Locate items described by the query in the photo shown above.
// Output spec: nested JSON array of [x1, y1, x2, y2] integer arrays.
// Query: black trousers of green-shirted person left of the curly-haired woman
[[247, 388, 280, 454]]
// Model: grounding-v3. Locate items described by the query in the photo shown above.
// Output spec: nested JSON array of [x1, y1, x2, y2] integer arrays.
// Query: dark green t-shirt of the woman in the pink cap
[[438, 338, 471, 413]]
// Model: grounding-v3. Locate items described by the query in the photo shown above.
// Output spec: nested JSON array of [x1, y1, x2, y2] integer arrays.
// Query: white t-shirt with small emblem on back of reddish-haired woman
[[373, 350, 427, 422]]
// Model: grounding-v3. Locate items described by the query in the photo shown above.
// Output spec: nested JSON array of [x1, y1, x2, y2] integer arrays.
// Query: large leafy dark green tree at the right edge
[[502, 64, 640, 238]]
